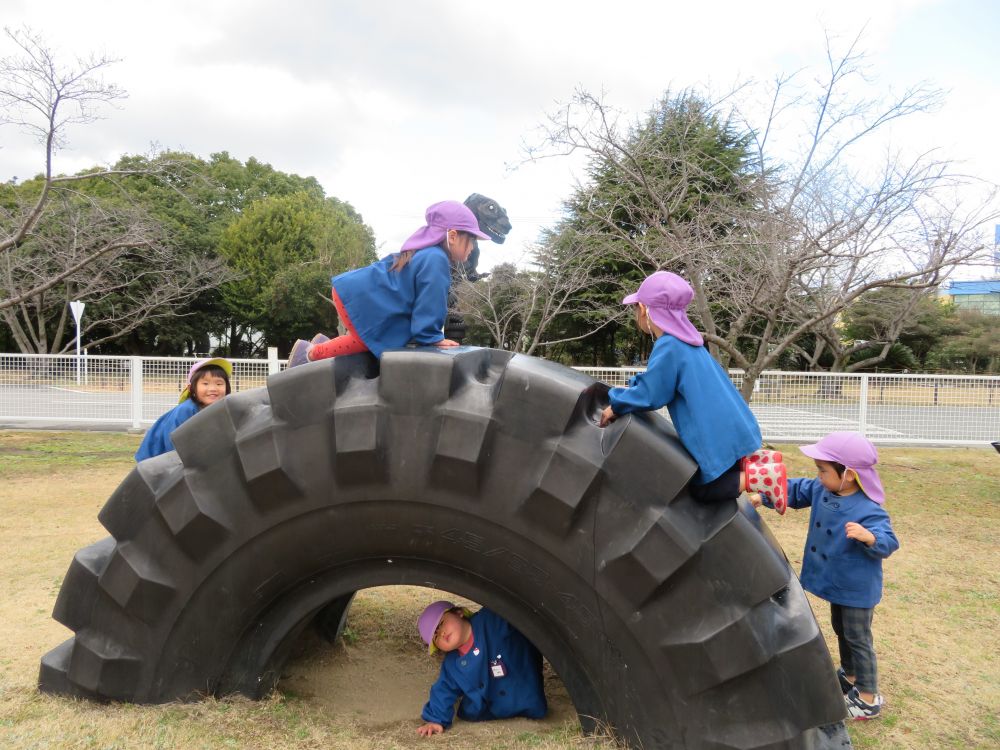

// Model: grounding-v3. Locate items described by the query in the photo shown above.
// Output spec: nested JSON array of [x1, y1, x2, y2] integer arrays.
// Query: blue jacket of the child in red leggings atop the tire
[[331, 245, 451, 358]]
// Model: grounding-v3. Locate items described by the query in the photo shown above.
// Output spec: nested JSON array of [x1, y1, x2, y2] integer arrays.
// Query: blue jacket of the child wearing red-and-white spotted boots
[[608, 334, 761, 484]]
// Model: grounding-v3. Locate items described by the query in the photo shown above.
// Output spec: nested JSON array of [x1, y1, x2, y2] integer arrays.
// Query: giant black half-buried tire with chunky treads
[[39, 349, 850, 749]]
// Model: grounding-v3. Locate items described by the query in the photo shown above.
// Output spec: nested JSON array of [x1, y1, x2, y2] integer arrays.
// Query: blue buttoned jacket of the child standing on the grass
[[764, 479, 899, 609]]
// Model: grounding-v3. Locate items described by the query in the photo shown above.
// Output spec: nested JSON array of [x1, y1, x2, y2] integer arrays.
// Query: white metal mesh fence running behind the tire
[[0, 354, 1000, 445]]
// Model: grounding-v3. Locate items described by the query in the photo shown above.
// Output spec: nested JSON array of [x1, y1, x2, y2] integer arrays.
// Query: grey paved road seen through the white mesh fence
[[0, 386, 1000, 443]]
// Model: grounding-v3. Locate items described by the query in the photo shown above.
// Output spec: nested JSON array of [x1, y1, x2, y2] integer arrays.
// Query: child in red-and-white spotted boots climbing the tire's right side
[[601, 271, 787, 513]]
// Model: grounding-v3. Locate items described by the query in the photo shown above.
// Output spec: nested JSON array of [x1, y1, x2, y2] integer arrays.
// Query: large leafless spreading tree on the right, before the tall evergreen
[[529, 31, 995, 400]]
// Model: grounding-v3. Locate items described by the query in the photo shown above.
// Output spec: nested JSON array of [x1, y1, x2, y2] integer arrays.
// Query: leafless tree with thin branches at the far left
[[0, 29, 231, 353]]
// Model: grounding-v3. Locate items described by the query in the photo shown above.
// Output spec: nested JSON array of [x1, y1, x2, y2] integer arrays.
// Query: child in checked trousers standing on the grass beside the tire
[[753, 432, 899, 719]]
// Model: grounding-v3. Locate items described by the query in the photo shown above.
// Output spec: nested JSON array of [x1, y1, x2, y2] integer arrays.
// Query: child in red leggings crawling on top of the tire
[[288, 201, 489, 367]]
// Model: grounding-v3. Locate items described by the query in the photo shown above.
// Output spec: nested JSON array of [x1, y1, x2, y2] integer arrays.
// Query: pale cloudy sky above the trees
[[0, 0, 1000, 270]]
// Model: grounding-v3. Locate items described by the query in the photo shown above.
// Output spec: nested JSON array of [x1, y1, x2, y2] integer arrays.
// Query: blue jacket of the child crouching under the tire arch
[[420, 607, 548, 729]]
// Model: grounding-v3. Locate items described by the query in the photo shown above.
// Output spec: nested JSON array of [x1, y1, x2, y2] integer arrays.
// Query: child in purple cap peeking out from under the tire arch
[[417, 601, 548, 737]]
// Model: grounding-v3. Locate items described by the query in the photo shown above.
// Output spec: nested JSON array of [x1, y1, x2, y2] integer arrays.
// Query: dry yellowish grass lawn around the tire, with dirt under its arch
[[0, 431, 1000, 750]]
